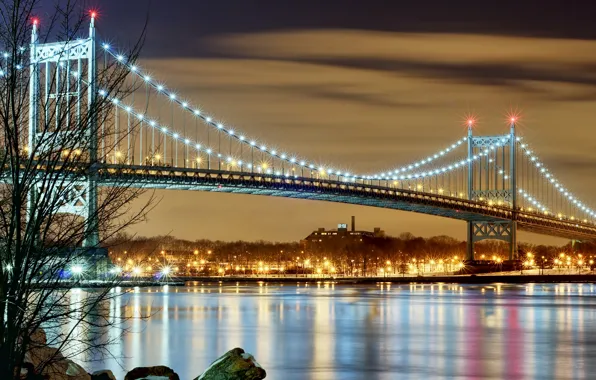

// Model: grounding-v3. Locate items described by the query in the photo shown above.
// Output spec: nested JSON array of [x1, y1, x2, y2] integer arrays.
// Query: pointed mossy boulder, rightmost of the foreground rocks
[[194, 348, 267, 380]]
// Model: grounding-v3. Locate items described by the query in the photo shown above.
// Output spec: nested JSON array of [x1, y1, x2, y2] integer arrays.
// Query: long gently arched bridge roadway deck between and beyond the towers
[[98, 164, 596, 240]]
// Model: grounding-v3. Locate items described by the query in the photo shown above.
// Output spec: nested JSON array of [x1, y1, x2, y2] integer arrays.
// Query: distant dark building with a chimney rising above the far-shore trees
[[301, 216, 385, 251]]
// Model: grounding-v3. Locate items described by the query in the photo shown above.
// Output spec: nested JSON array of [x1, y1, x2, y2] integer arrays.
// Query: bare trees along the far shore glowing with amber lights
[[110, 233, 596, 276]]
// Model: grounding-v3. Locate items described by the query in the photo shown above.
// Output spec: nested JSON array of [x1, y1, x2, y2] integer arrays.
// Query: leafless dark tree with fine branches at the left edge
[[0, 0, 152, 379]]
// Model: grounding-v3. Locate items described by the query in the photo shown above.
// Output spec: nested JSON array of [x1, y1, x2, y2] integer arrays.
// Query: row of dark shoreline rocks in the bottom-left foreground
[[21, 330, 267, 380]]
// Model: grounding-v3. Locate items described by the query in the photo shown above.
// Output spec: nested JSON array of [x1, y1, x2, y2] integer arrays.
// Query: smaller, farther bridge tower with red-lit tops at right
[[466, 118, 517, 260]]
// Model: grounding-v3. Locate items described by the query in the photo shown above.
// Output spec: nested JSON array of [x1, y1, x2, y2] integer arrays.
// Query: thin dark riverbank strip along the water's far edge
[[175, 274, 596, 285]]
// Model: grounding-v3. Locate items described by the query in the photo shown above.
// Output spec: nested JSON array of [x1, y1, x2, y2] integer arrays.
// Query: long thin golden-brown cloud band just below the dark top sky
[[205, 30, 596, 65]]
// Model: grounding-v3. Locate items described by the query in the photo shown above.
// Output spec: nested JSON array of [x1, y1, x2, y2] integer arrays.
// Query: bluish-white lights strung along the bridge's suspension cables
[[102, 43, 595, 219]]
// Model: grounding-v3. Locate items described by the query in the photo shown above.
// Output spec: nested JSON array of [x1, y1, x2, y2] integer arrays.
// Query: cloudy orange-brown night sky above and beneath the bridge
[[86, 0, 596, 243]]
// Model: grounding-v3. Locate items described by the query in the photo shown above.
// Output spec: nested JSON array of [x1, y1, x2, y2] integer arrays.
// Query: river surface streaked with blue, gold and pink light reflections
[[87, 283, 596, 380]]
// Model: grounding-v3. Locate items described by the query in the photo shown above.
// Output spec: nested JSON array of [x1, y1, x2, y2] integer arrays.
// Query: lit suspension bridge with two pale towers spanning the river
[[21, 15, 596, 260]]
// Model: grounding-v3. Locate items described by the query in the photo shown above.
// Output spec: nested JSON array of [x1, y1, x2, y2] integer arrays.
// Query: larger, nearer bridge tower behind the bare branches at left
[[28, 13, 99, 248]]
